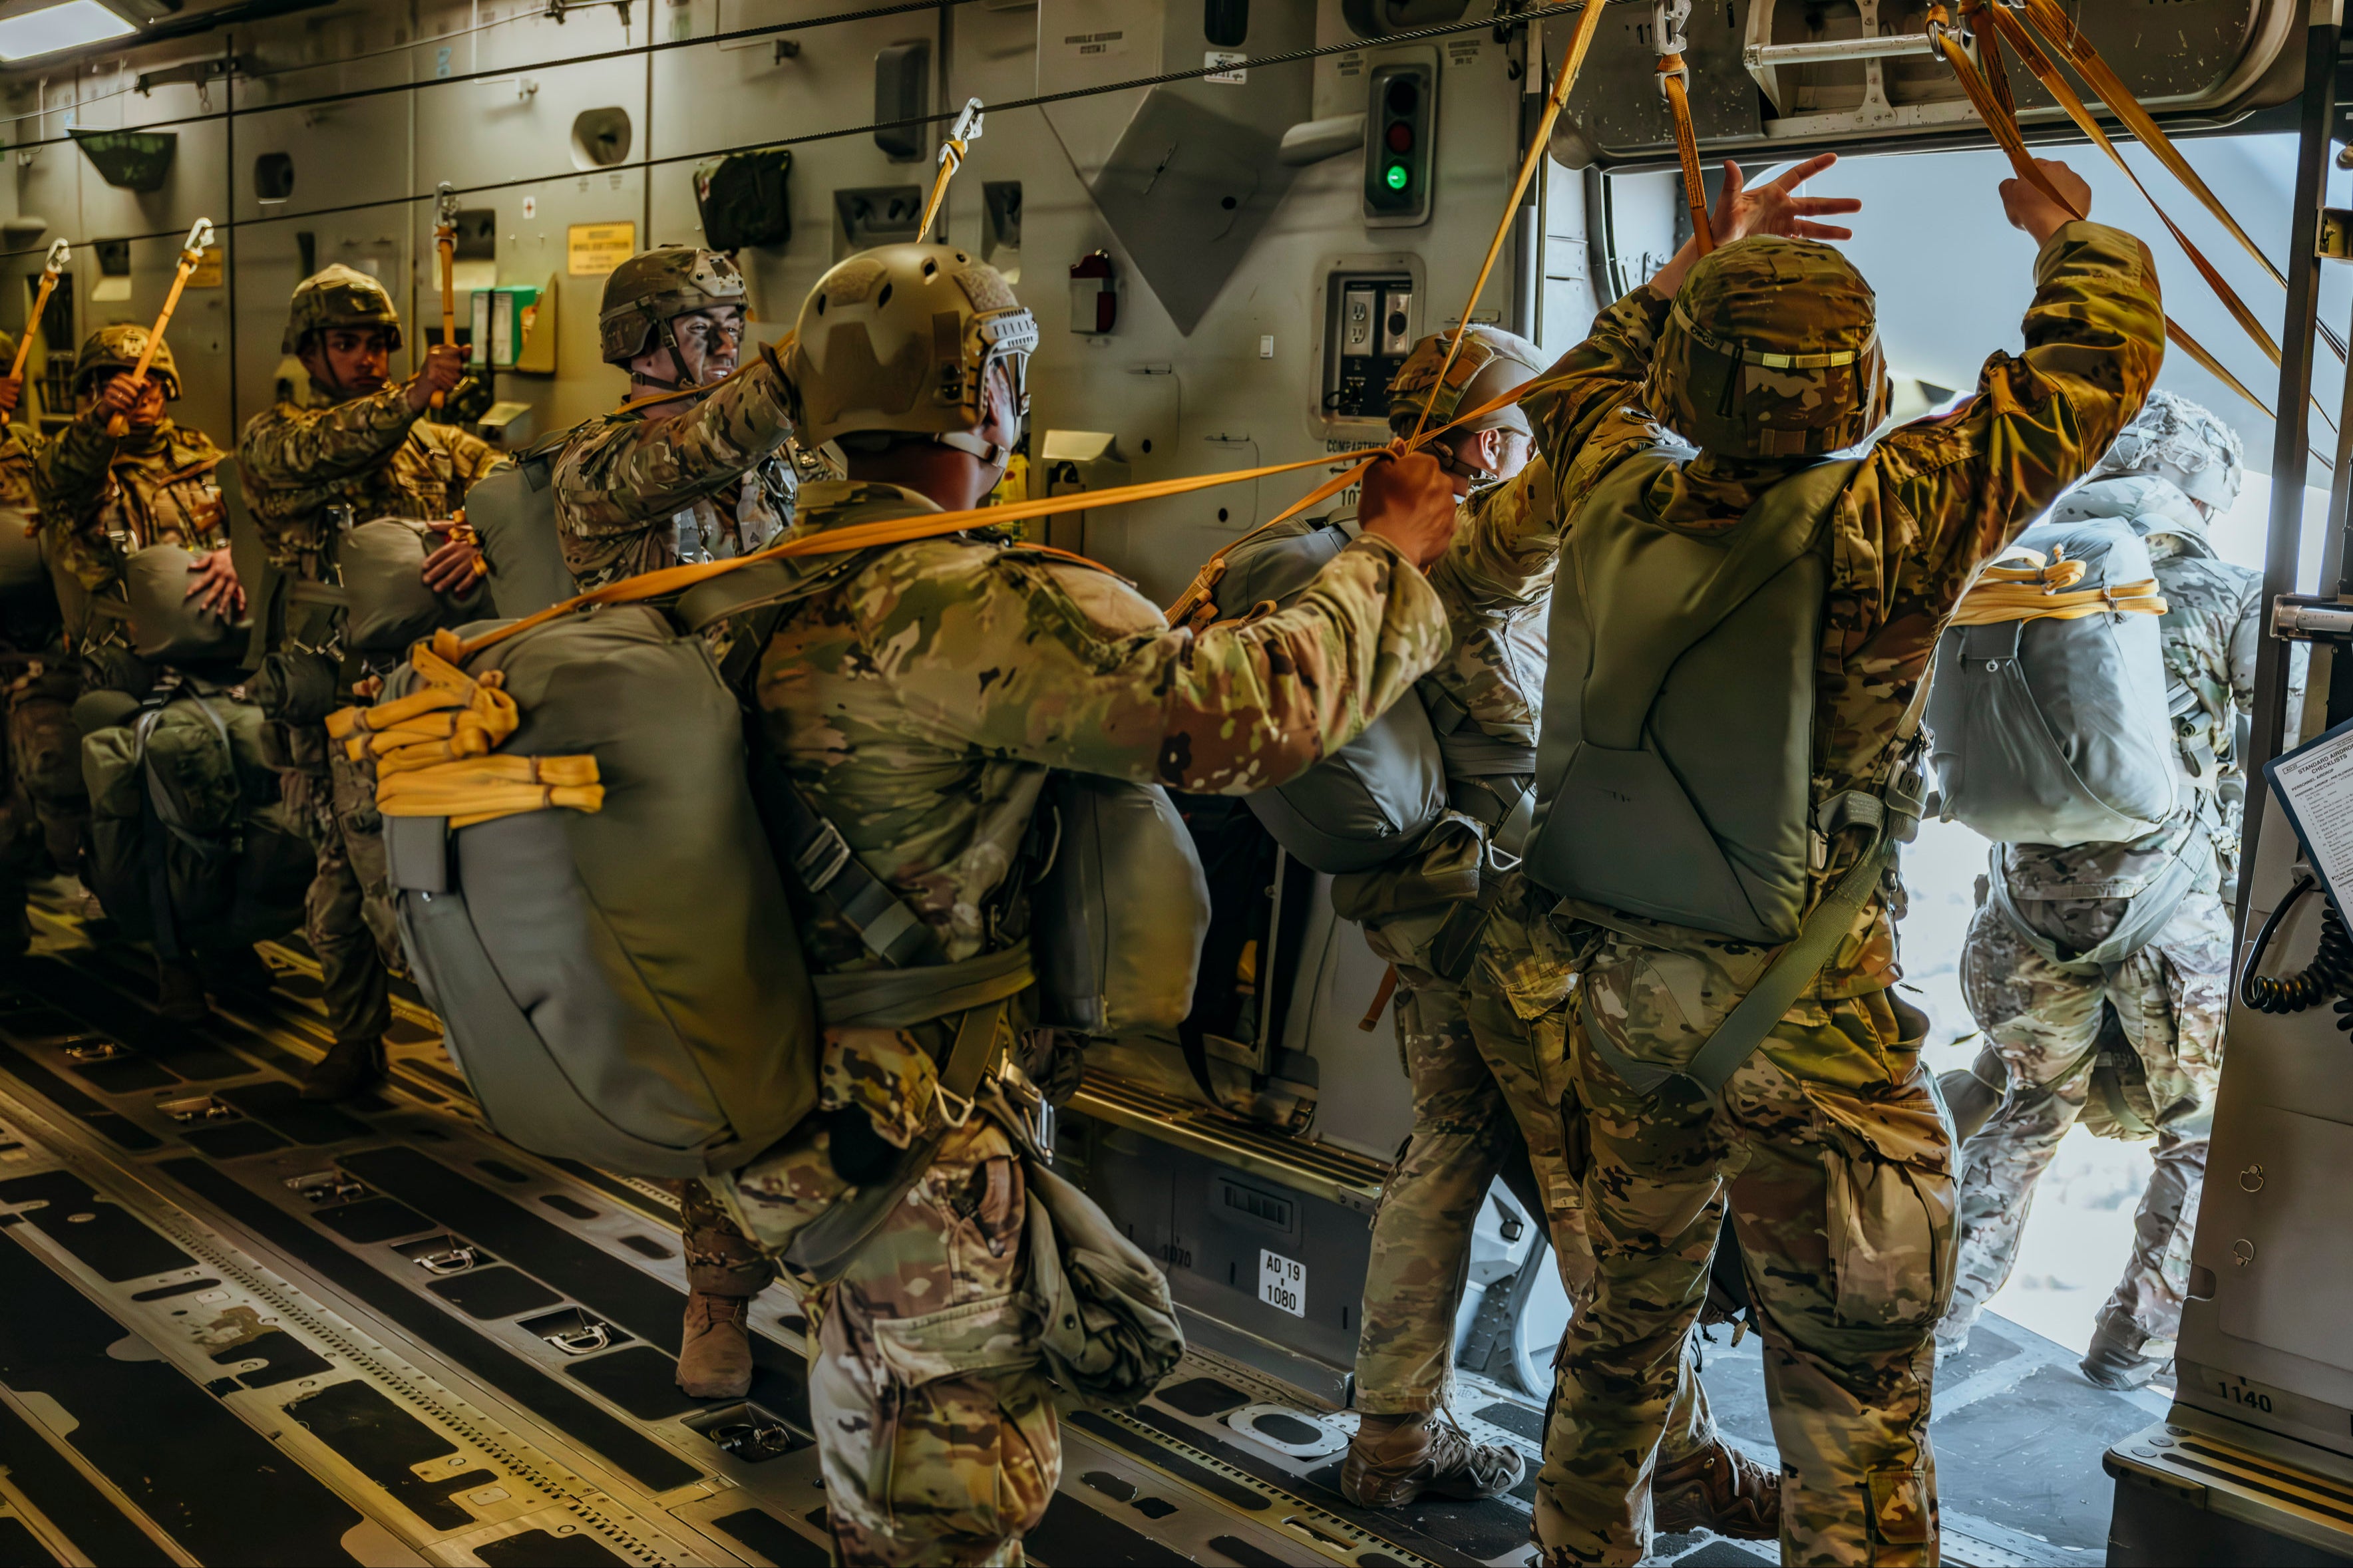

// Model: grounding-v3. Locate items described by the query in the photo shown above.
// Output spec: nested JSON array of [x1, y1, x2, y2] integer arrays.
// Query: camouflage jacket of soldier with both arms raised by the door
[[1520, 224, 2165, 997]]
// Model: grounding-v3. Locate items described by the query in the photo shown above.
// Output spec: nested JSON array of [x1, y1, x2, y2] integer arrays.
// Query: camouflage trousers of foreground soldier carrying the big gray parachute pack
[[711, 1030, 1061, 1568]]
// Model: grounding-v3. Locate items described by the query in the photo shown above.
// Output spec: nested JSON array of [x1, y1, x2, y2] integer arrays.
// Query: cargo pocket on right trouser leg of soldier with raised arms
[[1803, 1072, 1958, 1329]]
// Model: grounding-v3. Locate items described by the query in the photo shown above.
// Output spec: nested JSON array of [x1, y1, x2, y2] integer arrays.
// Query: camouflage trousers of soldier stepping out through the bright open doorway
[[1936, 891, 2231, 1354]]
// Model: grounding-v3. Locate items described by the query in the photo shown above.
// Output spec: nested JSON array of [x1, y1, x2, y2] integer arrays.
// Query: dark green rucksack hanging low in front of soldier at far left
[[78, 679, 313, 959]]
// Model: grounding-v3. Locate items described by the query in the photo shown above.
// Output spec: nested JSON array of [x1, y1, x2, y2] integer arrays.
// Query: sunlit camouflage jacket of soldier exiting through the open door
[[2002, 475, 2264, 931]]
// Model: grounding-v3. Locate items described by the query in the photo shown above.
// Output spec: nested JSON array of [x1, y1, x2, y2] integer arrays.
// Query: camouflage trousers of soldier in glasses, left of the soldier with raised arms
[[1356, 966, 1716, 1460]]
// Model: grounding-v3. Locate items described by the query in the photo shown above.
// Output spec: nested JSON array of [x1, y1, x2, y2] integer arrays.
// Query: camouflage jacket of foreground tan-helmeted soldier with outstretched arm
[[758, 480, 1445, 969]]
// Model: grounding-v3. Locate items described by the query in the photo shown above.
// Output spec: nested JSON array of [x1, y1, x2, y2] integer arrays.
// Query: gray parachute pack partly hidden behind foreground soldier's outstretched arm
[[1216, 517, 1447, 872]]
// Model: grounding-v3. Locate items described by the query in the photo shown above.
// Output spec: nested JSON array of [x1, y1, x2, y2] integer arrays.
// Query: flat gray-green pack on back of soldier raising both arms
[[1525, 449, 1857, 943]]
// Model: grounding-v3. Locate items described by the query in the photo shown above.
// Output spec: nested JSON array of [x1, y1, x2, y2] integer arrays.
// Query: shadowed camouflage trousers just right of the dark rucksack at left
[[282, 731, 400, 1041]]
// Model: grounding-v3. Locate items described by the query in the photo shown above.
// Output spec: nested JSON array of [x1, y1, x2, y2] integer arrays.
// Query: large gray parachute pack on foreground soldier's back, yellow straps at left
[[383, 607, 819, 1177]]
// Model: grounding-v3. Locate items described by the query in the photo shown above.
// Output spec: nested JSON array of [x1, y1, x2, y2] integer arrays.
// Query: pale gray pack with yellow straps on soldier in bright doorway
[[1927, 517, 2181, 844]]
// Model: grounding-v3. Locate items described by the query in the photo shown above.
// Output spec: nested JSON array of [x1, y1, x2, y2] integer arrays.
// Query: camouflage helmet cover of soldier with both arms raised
[[1645, 235, 1889, 458]]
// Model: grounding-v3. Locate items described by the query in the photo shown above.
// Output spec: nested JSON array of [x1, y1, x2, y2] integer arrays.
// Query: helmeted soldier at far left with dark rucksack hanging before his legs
[[33, 327, 259, 1022]]
